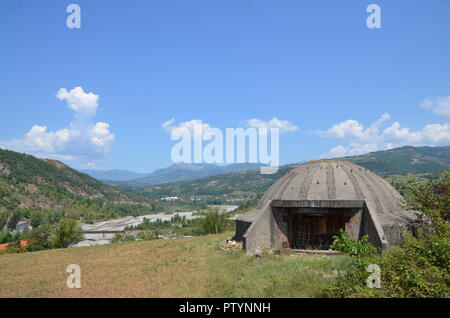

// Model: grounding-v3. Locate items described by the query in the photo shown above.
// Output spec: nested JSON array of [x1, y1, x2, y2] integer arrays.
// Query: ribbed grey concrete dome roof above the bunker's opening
[[251, 160, 411, 224]]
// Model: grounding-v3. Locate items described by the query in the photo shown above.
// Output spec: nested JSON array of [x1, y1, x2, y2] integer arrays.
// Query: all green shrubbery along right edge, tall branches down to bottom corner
[[324, 173, 450, 298]]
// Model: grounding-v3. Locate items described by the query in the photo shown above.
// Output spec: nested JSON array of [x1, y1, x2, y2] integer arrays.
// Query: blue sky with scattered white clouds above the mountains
[[0, 0, 450, 172]]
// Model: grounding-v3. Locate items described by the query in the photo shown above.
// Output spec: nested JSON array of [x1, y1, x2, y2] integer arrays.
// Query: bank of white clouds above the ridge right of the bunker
[[314, 97, 450, 158]]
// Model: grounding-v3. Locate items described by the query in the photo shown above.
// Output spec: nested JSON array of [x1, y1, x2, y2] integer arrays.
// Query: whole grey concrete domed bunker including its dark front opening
[[234, 160, 414, 253]]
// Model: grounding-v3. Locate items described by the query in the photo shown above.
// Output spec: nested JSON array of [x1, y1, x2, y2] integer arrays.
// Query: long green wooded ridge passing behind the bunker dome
[[119, 146, 450, 199]]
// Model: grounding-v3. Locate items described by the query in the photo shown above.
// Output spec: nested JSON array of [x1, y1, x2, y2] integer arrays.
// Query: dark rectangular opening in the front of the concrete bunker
[[291, 214, 345, 250]]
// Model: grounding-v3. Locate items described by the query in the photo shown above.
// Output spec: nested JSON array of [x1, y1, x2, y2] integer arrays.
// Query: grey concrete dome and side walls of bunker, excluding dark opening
[[236, 160, 415, 251]]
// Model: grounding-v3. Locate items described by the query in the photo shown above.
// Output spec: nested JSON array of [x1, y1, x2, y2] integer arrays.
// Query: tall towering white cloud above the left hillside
[[0, 87, 114, 166]]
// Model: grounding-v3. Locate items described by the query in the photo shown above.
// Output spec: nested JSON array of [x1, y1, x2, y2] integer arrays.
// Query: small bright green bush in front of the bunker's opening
[[330, 230, 377, 256]]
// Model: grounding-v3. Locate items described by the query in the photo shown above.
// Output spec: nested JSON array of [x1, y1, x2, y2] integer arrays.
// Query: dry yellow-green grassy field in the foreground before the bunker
[[0, 233, 349, 297]]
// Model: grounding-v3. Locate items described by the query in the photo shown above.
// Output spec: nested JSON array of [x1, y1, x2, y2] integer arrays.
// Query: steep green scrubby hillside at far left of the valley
[[0, 149, 154, 230]]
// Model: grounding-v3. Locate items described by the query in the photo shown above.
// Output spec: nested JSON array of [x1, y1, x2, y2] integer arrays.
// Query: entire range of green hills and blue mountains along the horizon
[[0, 146, 450, 219]]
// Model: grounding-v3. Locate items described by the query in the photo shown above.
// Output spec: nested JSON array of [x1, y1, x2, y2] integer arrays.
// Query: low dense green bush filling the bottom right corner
[[324, 235, 450, 298]]
